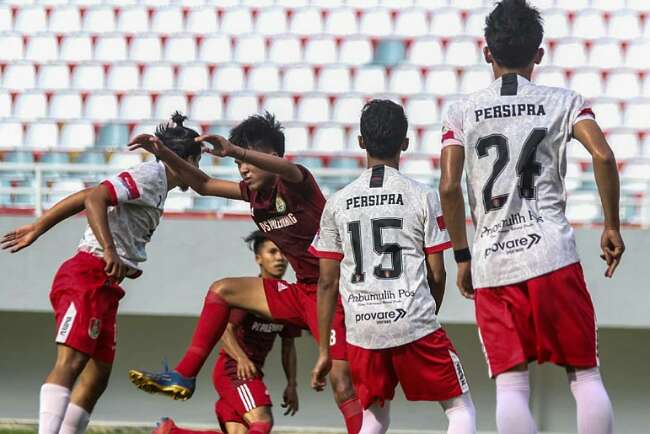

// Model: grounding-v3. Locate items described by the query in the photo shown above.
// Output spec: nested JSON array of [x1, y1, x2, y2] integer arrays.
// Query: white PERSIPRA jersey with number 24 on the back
[[442, 74, 594, 288]]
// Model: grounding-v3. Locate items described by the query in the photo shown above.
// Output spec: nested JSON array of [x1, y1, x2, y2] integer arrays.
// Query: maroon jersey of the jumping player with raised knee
[[239, 166, 325, 283]]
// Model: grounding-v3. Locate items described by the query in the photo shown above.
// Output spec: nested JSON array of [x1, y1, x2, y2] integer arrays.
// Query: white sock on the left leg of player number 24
[[496, 371, 537, 434]]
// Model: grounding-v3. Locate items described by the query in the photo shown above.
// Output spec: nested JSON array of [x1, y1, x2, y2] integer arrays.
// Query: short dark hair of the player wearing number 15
[[361, 99, 408, 158]]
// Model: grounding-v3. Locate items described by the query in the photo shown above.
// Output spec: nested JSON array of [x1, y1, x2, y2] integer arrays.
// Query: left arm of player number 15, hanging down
[[311, 258, 341, 392]]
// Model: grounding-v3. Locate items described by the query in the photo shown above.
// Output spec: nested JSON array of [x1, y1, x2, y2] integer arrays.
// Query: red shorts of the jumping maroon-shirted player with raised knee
[[264, 279, 347, 360]]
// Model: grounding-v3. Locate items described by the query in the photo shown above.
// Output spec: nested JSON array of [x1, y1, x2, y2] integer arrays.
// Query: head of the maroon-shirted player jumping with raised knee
[[229, 112, 284, 190]]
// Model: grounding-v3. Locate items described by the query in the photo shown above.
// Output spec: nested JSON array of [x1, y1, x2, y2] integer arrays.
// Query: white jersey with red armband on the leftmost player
[[79, 161, 167, 277]]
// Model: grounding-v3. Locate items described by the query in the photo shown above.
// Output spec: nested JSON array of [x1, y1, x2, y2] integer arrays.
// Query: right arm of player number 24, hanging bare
[[573, 119, 625, 277]]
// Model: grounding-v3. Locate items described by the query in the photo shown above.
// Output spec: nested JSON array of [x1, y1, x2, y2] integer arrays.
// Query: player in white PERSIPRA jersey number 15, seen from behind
[[311, 100, 476, 434]]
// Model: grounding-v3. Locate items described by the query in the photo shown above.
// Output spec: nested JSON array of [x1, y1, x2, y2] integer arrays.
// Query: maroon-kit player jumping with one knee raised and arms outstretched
[[124, 112, 363, 434]]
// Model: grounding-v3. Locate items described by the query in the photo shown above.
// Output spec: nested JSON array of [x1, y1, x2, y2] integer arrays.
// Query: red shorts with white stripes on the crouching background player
[[212, 355, 271, 432]]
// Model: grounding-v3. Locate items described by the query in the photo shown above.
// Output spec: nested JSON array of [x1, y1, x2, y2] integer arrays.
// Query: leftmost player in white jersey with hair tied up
[[2, 113, 201, 434]]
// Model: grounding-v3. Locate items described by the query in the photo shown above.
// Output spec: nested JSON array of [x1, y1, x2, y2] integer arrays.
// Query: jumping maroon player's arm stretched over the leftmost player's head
[[129, 134, 242, 200]]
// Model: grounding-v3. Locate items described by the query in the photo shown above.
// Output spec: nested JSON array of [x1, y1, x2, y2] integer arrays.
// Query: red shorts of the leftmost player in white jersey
[[50, 252, 124, 363]]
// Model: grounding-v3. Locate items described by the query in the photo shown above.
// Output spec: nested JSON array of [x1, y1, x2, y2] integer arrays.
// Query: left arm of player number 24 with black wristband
[[440, 145, 474, 299]]
